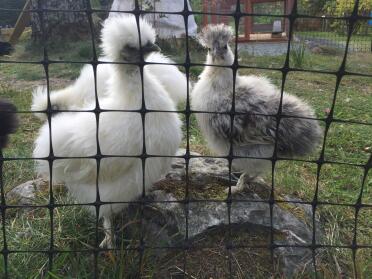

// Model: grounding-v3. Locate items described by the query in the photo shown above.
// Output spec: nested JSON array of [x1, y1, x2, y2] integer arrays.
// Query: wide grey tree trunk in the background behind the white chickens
[[31, 0, 90, 42]]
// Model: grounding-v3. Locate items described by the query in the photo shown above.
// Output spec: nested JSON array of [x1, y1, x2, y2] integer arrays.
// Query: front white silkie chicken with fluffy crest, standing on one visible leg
[[33, 15, 181, 248]]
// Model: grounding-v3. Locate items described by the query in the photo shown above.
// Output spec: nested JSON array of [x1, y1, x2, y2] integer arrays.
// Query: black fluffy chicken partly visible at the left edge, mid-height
[[0, 100, 18, 149]]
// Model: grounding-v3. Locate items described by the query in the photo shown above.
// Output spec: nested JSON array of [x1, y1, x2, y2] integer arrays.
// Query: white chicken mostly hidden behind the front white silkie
[[31, 40, 191, 120]]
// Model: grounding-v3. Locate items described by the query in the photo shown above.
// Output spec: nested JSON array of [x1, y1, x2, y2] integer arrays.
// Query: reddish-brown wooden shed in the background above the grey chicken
[[203, 0, 294, 42]]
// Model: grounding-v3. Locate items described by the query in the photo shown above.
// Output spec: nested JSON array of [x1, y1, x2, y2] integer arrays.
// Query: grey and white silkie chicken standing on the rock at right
[[191, 24, 321, 192]]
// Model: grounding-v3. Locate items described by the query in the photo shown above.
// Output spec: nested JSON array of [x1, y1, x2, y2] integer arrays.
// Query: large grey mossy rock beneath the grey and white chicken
[[118, 150, 319, 277]]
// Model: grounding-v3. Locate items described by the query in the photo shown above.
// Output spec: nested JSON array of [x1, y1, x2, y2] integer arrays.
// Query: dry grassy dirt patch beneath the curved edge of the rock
[[155, 225, 281, 279]]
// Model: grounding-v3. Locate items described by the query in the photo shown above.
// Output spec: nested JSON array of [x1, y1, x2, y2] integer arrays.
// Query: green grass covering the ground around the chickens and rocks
[[0, 36, 372, 278]]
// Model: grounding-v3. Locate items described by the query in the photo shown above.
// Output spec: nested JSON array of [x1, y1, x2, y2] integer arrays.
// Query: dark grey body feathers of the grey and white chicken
[[209, 88, 320, 156]]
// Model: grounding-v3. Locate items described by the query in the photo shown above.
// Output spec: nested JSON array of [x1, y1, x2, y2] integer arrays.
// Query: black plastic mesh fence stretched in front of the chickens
[[0, 0, 372, 278]]
